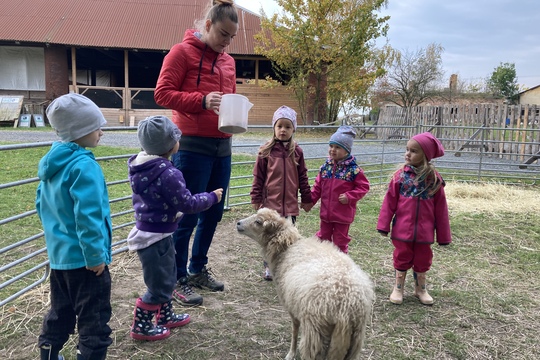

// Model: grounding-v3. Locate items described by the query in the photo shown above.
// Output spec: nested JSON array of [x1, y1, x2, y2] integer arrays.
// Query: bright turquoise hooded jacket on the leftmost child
[[36, 142, 112, 270]]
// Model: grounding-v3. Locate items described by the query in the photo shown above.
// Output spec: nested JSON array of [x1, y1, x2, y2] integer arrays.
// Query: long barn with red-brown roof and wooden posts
[[0, 0, 298, 126]]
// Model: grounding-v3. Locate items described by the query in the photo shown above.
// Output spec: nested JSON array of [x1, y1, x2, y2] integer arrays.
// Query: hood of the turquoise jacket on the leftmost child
[[38, 141, 94, 181]]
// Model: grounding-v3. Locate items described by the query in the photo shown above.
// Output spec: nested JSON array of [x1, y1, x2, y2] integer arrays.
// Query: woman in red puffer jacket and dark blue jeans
[[154, 0, 238, 306]]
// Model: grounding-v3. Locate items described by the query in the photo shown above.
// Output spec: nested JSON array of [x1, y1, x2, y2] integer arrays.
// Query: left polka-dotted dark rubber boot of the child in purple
[[129, 298, 171, 341]]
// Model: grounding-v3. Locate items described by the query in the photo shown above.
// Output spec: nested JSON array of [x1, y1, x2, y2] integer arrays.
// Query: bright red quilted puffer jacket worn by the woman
[[154, 30, 236, 138]]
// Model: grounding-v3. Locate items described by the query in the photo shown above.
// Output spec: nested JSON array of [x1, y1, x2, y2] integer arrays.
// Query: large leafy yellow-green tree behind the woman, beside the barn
[[255, 0, 389, 124]]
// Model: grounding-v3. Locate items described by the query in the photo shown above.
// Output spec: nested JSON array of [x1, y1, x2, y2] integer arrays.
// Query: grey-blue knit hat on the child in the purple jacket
[[137, 115, 182, 155]]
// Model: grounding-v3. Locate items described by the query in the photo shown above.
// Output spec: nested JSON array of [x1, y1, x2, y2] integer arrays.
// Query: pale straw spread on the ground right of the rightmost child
[[445, 182, 540, 214]]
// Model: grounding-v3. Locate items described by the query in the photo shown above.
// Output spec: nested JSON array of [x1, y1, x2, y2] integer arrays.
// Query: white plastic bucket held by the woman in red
[[214, 94, 253, 134]]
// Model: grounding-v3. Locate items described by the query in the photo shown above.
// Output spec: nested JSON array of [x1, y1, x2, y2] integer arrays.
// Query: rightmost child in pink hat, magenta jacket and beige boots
[[377, 132, 452, 305]]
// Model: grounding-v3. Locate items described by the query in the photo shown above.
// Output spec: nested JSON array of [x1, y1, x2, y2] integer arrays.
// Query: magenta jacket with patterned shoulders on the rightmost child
[[377, 166, 452, 244]]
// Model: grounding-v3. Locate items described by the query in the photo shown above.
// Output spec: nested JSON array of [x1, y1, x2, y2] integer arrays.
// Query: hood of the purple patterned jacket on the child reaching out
[[128, 152, 170, 194]]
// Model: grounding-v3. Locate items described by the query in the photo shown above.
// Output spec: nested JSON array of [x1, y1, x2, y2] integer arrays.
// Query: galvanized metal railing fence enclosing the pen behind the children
[[0, 121, 540, 306]]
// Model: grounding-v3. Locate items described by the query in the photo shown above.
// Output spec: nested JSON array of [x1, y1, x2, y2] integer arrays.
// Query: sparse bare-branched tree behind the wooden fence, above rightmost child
[[374, 44, 444, 120]]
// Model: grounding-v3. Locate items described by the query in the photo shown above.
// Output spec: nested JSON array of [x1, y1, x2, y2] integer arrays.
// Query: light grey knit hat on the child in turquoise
[[45, 93, 107, 142]]
